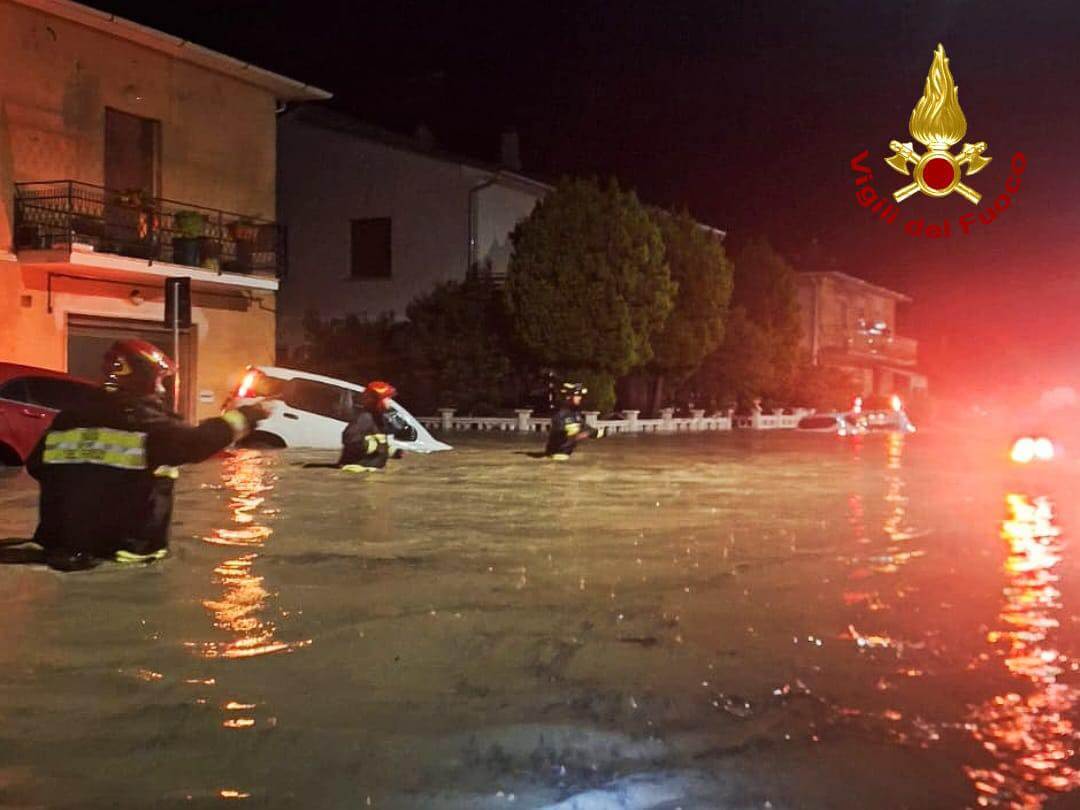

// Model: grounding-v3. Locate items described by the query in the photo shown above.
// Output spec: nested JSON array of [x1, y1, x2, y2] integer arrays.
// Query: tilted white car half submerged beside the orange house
[[227, 366, 454, 453]]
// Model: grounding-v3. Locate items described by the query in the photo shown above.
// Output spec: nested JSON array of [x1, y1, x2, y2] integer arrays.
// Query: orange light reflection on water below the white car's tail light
[[199, 450, 299, 659]]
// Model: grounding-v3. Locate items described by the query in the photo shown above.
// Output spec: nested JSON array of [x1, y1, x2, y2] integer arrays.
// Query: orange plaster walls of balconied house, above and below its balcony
[[0, 0, 276, 425]]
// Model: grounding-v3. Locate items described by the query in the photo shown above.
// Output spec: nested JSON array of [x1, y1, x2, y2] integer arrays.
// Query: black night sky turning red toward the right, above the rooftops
[[79, 0, 1080, 401]]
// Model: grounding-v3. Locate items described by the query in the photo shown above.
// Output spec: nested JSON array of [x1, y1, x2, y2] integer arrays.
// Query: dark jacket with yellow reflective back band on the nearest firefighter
[[26, 392, 243, 557]]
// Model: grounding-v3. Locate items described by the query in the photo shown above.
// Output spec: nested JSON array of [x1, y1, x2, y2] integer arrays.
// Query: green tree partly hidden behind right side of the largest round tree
[[649, 210, 733, 410]]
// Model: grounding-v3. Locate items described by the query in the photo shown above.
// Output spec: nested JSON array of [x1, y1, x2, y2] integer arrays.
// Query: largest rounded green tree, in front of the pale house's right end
[[507, 180, 675, 410]]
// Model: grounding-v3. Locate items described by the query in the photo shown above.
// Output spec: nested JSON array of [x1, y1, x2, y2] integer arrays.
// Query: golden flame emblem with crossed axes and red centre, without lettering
[[885, 44, 991, 203]]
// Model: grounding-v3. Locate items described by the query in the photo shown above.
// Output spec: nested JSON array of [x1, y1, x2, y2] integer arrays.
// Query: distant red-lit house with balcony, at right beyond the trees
[[797, 272, 927, 395]]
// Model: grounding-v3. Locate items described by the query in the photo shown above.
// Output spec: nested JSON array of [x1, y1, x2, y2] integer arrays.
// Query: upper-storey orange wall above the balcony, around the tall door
[[0, 0, 276, 251]]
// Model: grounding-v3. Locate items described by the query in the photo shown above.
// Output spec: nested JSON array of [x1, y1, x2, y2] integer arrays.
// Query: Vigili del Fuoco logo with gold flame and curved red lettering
[[851, 44, 1027, 239]]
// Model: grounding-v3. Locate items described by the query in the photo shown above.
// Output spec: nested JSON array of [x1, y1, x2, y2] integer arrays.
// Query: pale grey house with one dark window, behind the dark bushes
[[278, 105, 551, 353]]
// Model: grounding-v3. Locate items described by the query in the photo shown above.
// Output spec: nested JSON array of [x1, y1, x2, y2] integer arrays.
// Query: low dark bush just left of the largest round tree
[[405, 274, 511, 413]]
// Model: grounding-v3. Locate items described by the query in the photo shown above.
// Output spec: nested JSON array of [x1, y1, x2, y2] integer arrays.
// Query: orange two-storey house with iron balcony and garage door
[[0, 0, 329, 418]]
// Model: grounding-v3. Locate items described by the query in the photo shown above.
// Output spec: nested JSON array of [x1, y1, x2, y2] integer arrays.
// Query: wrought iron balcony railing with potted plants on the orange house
[[14, 180, 285, 278]]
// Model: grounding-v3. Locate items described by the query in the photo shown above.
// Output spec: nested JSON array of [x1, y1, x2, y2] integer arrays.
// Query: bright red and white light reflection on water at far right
[[966, 494, 1080, 810]]
